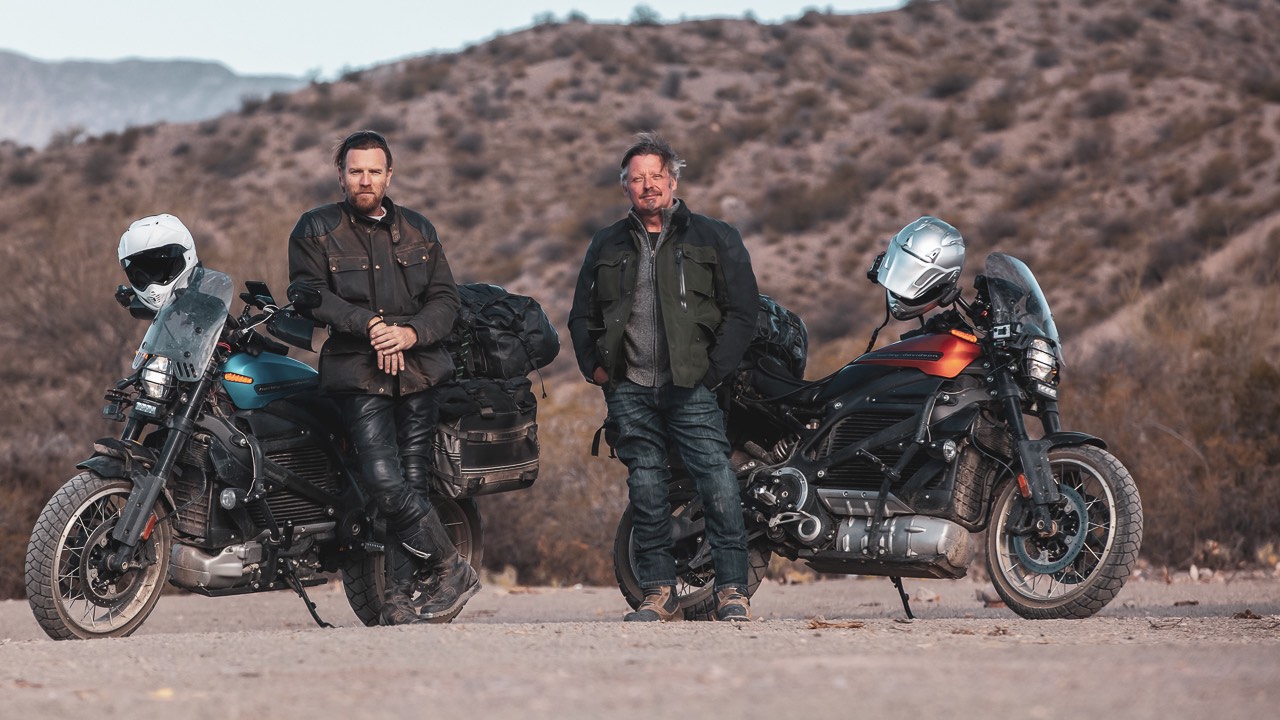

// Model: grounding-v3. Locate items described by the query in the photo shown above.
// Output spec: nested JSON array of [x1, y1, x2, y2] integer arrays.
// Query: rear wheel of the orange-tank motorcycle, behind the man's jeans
[[613, 497, 771, 620]]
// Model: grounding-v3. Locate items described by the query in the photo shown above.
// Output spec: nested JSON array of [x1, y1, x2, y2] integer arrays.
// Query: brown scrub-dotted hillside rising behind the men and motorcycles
[[0, 0, 1280, 594]]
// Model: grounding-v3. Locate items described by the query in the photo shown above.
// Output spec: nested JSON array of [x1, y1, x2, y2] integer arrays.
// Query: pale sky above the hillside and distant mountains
[[0, 0, 904, 82]]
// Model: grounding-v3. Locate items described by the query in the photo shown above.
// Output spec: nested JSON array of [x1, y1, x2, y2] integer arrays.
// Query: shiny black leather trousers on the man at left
[[338, 389, 439, 532]]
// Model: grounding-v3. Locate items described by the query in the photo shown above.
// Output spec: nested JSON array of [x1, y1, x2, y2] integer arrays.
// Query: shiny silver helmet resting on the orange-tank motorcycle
[[876, 215, 964, 320]]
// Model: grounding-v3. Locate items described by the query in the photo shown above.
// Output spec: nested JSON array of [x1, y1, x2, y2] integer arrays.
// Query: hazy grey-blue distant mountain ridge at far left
[[0, 50, 305, 147]]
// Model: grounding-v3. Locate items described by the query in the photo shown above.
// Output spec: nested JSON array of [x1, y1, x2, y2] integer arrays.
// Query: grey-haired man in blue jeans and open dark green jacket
[[568, 133, 759, 621]]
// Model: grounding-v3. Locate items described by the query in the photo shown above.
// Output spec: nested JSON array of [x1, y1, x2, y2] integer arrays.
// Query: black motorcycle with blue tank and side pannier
[[26, 268, 538, 639]]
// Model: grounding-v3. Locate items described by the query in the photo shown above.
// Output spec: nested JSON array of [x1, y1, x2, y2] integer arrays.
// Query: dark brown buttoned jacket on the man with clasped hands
[[289, 199, 458, 395]]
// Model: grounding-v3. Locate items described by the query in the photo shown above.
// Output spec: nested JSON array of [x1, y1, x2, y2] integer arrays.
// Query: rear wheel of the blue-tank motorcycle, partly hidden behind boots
[[342, 497, 484, 626]]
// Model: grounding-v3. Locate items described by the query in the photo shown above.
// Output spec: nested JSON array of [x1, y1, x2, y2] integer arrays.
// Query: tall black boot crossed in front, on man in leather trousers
[[398, 507, 480, 623]]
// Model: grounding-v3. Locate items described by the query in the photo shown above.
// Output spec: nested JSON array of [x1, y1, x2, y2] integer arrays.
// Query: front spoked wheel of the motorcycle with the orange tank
[[987, 446, 1143, 620]]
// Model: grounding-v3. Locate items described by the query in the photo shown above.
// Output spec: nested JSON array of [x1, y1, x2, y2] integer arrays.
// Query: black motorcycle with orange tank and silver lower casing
[[613, 252, 1143, 619]]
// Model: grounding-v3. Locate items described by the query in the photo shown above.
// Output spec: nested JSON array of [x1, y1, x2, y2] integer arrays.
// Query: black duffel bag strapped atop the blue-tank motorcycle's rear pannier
[[444, 283, 559, 379]]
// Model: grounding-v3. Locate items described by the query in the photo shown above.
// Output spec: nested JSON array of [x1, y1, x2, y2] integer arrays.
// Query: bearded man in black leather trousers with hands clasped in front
[[289, 131, 480, 625]]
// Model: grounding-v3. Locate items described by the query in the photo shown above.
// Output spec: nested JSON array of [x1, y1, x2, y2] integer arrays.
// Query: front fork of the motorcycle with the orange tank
[[995, 369, 1061, 537]]
